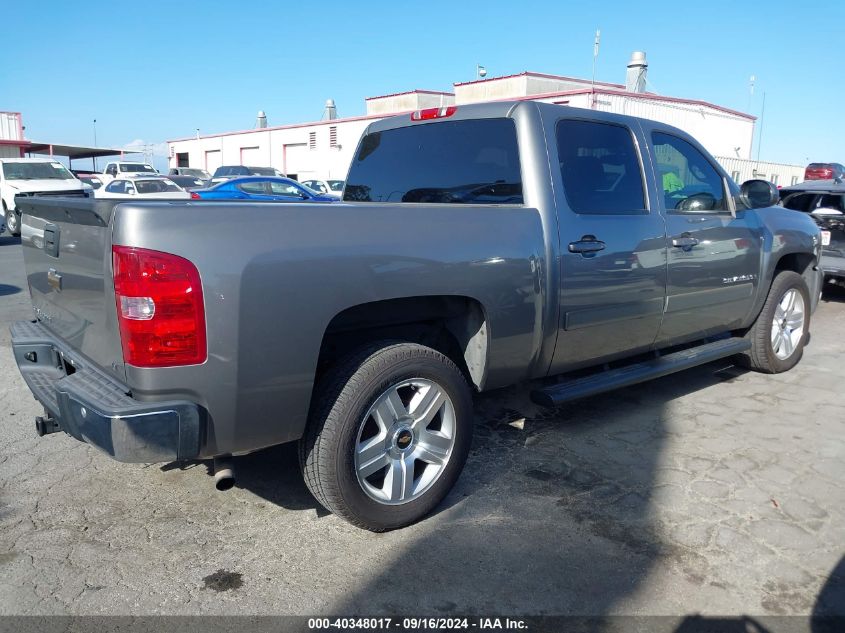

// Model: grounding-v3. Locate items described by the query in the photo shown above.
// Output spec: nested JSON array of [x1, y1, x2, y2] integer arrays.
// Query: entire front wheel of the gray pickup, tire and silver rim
[[744, 270, 810, 374]]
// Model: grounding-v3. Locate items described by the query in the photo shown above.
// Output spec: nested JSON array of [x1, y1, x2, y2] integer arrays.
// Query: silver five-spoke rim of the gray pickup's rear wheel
[[355, 378, 456, 505]]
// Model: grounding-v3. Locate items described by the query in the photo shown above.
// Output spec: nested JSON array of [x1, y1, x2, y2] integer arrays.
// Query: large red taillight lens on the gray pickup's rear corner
[[112, 246, 208, 367]]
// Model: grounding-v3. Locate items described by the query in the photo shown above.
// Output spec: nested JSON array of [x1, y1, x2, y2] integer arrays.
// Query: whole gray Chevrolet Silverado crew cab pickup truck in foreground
[[12, 101, 821, 531]]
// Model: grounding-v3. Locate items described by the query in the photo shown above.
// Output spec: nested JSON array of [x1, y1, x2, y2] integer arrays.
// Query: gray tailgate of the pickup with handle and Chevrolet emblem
[[18, 197, 125, 378]]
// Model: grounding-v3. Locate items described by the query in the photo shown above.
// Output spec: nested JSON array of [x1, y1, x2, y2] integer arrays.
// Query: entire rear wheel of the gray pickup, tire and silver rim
[[300, 343, 472, 532]]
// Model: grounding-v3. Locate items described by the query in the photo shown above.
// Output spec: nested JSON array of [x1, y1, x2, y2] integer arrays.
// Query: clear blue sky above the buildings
[[0, 0, 845, 164]]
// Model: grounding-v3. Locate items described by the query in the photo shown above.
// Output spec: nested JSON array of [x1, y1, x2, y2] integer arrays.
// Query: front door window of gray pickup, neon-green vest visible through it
[[652, 132, 727, 212]]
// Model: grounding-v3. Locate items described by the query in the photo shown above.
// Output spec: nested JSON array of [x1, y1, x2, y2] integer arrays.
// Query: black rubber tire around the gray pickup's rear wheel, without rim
[[299, 341, 473, 532]]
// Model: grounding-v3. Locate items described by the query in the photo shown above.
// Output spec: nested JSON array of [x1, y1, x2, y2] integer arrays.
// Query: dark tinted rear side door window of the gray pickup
[[557, 120, 646, 215]]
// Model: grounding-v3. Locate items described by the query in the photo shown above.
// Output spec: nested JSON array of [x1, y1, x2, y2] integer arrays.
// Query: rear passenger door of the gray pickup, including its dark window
[[551, 117, 666, 373]]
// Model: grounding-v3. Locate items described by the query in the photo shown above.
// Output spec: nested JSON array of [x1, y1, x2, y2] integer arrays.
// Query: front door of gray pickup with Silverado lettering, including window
[[649, 129, 762, 346]]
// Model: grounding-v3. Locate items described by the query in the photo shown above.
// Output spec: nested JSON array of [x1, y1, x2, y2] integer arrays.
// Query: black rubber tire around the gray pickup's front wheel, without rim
[[741, 270, 810, 374]]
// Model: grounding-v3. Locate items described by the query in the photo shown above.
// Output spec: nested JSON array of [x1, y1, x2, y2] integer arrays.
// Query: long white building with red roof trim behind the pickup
[[168, 53, 791, 180]]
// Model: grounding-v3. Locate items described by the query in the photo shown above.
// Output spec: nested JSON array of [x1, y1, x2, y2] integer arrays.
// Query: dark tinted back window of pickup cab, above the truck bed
[[343, 119, 523, 204]]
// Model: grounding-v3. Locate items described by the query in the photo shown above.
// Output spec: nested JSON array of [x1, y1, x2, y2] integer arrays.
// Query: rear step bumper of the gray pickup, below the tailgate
[[12, 321, 202, 463]]
